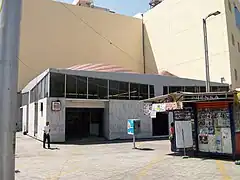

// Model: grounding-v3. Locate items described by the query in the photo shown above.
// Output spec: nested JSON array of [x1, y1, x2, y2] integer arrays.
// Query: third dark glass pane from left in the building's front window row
[[77, 76, 87, 99]]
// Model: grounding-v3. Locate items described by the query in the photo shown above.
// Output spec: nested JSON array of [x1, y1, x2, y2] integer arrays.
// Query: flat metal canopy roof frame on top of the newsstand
[[140, 91, 236, 103]]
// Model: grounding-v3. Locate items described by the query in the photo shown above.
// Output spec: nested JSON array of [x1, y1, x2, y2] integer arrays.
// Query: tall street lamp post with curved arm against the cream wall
[[203, 11, 221, 92]]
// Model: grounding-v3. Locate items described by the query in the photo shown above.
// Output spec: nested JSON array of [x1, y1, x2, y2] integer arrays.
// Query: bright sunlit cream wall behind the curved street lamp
[[144, 0, 231, 85]]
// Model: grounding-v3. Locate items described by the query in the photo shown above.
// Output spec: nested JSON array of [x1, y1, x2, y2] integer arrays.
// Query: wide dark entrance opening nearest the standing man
[[65, 108, 104, 140]]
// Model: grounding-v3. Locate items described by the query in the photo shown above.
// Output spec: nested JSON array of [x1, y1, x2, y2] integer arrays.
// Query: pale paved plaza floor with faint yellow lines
[[16, 133, 240, 180]]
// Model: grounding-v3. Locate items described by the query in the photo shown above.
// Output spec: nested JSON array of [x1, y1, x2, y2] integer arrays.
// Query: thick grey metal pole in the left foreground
[[0, 0, 21, 180]]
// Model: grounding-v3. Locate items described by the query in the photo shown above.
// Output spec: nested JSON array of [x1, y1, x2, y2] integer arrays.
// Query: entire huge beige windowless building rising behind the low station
[[19, 0, 240, 90]]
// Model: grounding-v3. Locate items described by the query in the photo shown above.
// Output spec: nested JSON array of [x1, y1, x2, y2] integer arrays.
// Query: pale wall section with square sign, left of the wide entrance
[[47, 98, 66, 142]]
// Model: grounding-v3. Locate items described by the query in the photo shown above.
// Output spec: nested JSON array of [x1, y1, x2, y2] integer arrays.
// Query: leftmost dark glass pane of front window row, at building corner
[[50, 73, 65, 97]]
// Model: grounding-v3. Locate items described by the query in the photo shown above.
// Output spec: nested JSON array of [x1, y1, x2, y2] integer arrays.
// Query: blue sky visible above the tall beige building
[[59, 0, 150, 16]]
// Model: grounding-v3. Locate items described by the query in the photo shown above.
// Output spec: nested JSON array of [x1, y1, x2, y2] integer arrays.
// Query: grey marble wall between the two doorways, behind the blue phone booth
[[109, 100, 152, 140]]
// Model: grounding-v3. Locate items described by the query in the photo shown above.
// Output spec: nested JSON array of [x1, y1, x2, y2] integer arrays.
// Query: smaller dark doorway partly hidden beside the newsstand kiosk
[[152, 112, 169, 136]]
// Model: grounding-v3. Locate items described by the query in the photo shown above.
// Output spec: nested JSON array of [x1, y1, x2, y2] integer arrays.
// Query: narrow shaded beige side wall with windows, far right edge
[[224, 0, 240, 88]]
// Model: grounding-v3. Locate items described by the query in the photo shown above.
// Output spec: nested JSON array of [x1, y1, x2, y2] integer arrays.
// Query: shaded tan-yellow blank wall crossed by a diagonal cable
[[18, 0, 143, 90]]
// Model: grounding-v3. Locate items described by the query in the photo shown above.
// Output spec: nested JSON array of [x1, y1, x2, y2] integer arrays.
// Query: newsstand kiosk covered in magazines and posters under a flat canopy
[[143, 91, 240, 159]]
